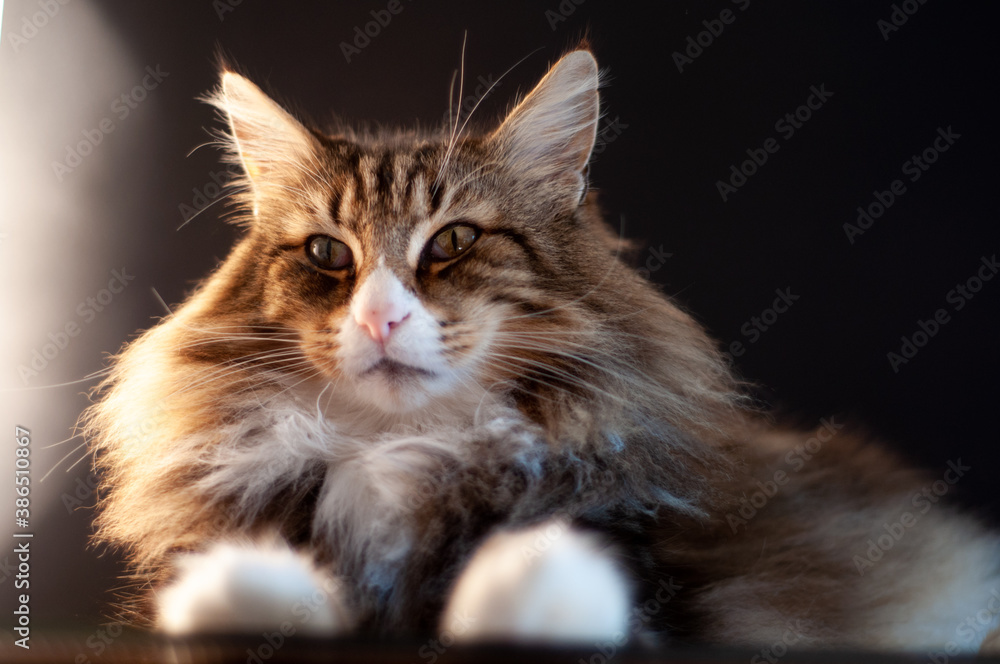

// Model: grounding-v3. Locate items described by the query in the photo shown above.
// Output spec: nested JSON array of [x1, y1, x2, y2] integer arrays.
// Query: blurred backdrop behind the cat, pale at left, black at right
[[0, 0, 1000, 644]]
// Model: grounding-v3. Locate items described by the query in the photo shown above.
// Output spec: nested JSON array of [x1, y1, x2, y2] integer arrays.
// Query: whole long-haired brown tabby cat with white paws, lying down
[[84, 46, 1000, 652]]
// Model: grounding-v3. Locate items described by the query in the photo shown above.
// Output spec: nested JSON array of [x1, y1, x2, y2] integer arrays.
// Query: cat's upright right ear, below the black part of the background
[[490, 50, 599, 202]]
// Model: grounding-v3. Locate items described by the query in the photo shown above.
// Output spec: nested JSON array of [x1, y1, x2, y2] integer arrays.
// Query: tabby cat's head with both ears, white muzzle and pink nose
[[189, 50, 610, 411]]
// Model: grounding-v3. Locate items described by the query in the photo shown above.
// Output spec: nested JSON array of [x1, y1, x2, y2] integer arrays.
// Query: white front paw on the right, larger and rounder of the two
[[441, 521, 632, 642]]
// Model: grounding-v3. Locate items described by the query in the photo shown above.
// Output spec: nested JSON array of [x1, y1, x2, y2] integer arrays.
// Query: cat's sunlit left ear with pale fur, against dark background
[[208, 71, 315, 214]]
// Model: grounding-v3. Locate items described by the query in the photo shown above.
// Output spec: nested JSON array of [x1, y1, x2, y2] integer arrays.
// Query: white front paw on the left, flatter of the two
[[156, 544, 353, 636]]
